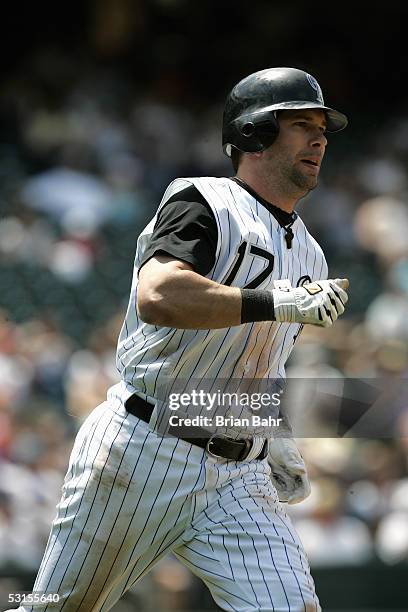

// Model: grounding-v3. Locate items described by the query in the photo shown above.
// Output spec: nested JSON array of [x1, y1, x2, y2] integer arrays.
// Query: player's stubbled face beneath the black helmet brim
[[264, 109, 327, 193]]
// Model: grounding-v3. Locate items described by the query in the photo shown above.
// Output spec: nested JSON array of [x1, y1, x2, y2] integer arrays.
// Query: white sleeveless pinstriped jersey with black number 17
[[109, 177, 327, 400]]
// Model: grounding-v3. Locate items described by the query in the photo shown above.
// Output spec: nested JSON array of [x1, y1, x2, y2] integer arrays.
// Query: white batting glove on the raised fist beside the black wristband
[[272, 278, 349, 327]]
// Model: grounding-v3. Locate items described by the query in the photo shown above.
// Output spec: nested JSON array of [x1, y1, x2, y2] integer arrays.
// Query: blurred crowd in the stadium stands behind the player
[[0, 46, 408, 608]]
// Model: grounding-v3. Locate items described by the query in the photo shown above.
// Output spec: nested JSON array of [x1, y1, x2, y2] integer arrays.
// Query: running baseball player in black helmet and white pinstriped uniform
[[7, 68, 347, 612]]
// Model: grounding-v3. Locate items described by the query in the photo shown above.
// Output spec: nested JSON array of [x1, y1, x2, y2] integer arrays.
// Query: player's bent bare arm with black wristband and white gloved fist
[[137, 255, 348, 329]]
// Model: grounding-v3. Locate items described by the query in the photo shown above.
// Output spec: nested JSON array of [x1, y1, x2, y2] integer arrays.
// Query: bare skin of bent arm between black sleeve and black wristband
[[137, 255, 242, 329]]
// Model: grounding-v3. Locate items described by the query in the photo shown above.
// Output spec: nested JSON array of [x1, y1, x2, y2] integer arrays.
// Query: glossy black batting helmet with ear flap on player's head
[[222, 68, 347, 157]]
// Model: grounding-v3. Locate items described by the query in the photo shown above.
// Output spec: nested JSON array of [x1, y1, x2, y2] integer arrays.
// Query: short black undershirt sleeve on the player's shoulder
[[140, 185, 218, 276]]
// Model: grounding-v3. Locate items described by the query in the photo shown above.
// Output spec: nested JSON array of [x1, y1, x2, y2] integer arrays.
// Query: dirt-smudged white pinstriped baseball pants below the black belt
[[11, 401, 321, 612]]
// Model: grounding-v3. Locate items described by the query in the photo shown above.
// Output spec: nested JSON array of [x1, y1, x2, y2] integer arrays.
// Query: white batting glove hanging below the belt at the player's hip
[[268, 438, 311, 504]]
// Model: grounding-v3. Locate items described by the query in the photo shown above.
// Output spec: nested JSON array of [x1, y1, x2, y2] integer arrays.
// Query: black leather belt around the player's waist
[[125, 395, 268, 461]]
